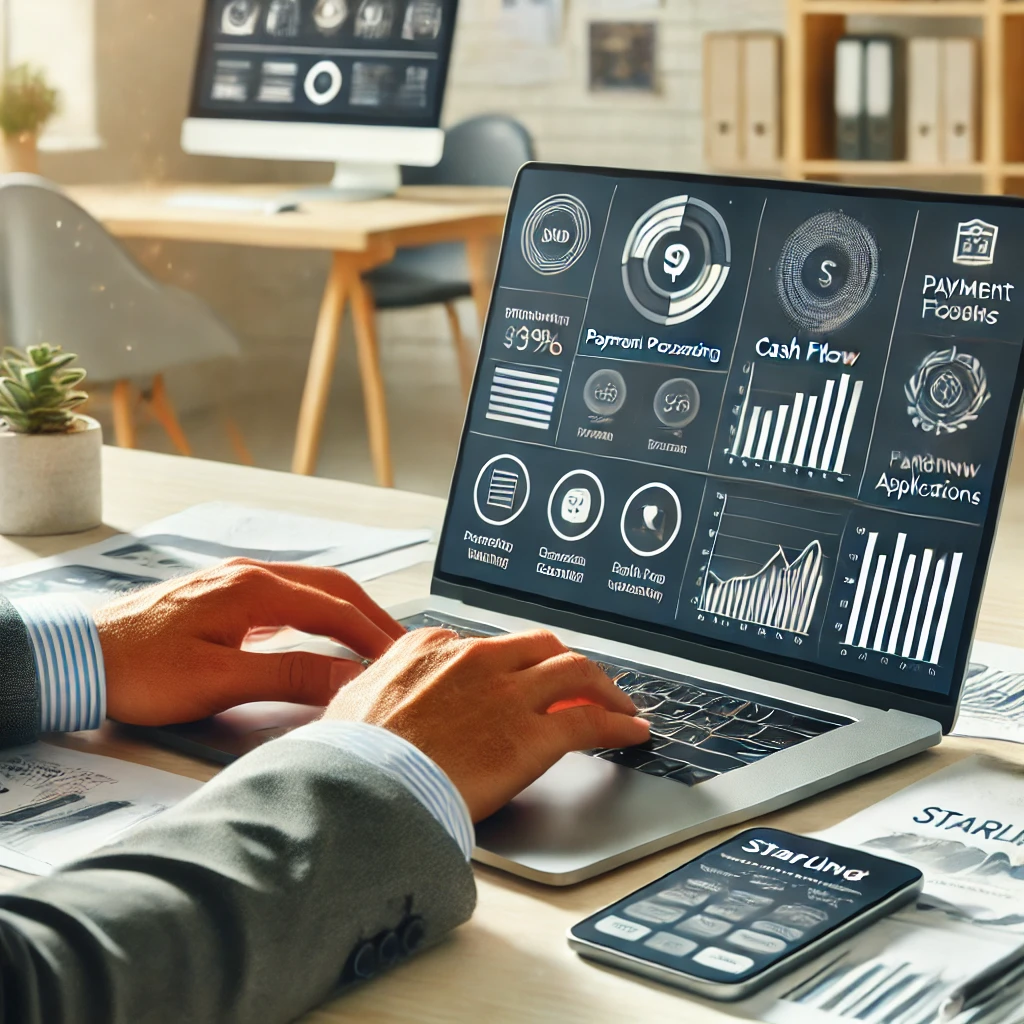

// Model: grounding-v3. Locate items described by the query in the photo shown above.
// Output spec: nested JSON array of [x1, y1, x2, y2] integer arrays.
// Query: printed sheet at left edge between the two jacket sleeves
[[0, 743, 201, 874]]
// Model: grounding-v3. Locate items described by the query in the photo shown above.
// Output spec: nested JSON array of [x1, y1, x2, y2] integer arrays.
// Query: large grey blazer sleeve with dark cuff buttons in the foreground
[[0, 738, 475, 1024]]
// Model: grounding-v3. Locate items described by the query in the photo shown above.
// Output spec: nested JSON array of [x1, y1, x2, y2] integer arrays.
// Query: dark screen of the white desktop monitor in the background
[[191, 0, 457, 128]]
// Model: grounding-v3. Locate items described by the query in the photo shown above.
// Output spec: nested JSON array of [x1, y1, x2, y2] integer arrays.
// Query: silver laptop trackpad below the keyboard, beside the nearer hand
[[476, 754, 714, 873]]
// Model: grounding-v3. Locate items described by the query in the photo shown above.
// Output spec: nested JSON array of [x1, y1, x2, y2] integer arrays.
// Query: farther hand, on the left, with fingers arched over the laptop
[[95, 558, 406, 725]]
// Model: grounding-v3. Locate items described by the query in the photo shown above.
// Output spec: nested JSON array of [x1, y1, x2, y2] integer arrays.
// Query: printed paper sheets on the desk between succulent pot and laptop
[[0, 502, 435, 603]]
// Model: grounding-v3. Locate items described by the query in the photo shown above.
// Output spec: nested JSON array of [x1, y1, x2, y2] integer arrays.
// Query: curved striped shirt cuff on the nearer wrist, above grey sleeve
[[278, 721, 475, 860]]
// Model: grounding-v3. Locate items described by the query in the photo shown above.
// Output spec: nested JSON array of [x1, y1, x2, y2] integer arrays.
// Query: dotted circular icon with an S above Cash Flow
[[775, 210, 879, 333]]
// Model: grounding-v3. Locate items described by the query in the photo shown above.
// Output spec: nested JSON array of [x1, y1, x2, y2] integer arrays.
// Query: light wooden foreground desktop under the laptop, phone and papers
[[0, 449, 1024, 1024]]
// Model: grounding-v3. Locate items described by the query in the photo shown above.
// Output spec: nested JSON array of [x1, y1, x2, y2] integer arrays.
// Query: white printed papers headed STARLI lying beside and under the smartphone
[[740, 758, 1024, 1024]]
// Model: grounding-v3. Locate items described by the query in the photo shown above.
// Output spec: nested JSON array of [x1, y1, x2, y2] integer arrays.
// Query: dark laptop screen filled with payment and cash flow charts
[[438, 165, 1024, 702]]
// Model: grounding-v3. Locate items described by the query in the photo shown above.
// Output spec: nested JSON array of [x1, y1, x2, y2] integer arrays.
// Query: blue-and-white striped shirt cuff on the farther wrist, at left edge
[[13, 596, 106, 732]]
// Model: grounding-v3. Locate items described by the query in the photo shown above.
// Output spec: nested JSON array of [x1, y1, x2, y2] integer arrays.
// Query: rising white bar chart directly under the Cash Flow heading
[[729, 362, 864, 476]]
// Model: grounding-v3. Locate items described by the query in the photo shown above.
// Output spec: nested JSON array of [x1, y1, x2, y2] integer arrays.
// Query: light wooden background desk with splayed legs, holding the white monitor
[[68, 184, 508, 487]]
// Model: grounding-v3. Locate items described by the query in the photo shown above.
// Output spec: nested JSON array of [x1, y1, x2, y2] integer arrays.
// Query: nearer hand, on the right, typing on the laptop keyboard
[[324, 630, 650, 821]]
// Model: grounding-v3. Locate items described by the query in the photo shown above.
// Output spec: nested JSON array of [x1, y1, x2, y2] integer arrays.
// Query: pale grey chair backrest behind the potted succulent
[[0, 174, 241, 383]]
